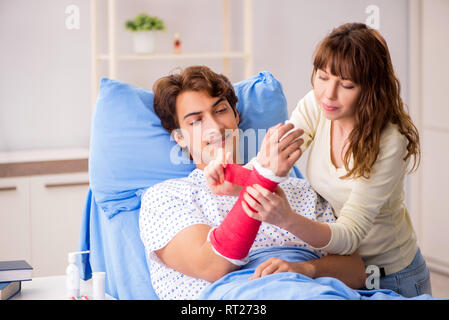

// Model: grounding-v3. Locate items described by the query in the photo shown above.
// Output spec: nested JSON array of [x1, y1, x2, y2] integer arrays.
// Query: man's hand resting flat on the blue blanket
[[249, 258, 314, 280]]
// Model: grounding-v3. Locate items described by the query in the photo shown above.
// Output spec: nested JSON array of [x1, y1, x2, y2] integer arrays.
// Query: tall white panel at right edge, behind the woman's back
[[411, 0, 449, 275]]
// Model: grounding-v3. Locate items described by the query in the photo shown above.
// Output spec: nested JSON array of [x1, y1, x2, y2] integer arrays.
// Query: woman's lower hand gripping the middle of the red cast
[[242, 184, 297, 229]]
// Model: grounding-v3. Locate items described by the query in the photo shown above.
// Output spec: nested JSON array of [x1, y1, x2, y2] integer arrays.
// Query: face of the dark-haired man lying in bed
[[174, 91, 239, 169]]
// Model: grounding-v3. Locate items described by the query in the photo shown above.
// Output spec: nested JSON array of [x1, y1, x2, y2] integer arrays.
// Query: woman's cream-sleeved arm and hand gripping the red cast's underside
[[242, 135, 407, 255]]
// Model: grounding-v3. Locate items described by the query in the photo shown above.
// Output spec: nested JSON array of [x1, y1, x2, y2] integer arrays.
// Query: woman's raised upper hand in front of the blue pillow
[[257, 123, 304, 177]]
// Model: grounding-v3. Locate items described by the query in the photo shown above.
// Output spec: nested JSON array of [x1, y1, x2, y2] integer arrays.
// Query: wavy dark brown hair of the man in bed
[[153, 66, 237, 133]]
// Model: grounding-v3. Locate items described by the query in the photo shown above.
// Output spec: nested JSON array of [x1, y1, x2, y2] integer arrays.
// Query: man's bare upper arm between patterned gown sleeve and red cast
[[155, 224, 239, 282]]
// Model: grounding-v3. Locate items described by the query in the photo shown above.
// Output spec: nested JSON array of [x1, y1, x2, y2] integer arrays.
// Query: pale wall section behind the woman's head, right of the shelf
[[248, 0, 407, 110]]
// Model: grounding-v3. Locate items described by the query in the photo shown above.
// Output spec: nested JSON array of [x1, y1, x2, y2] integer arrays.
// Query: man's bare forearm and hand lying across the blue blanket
[[251, 253, 366, 289]]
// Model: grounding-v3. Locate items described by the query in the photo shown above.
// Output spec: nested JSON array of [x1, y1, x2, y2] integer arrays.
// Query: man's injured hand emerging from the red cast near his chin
[[204, 148, 242, 196]]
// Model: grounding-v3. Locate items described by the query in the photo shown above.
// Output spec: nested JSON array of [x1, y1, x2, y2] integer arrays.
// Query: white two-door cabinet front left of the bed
[[0, 168, 89, 277]]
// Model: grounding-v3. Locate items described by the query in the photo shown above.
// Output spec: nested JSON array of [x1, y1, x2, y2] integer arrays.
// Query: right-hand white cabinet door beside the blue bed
[[30, 172, 88, 277]]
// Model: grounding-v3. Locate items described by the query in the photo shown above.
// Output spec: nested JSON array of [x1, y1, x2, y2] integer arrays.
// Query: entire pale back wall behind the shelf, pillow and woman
[[0, 0, 408, 155]]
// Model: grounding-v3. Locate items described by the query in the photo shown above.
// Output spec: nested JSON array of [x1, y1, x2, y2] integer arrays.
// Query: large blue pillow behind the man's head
[[89, 72, 300, 218]]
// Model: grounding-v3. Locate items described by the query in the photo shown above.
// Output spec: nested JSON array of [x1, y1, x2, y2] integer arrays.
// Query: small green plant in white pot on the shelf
[[125, 13, 165, 53]]
